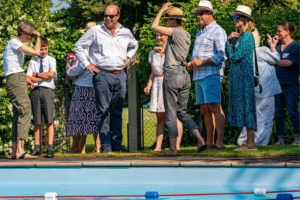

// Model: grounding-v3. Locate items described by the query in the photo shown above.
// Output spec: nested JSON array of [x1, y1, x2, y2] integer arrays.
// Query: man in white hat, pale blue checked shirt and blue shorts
[[186, 0, 227, 149]]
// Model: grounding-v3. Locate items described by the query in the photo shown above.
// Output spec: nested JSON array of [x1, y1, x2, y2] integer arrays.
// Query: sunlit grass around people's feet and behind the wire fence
[[64, 108, 300, 158]]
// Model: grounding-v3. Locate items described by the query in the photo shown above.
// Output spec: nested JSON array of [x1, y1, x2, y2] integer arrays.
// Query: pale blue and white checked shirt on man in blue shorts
[[191, 21, 227, 80]]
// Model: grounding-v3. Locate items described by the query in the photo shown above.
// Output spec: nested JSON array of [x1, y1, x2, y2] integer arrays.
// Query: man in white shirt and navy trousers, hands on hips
[[74, 4, 138, 153]]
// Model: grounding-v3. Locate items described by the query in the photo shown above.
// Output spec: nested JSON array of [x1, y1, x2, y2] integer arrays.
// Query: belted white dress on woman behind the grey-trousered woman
[[149, 51, 165, 112]]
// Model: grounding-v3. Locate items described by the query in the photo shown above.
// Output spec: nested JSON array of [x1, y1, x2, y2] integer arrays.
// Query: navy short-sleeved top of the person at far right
[[275, 41, 300, 85]]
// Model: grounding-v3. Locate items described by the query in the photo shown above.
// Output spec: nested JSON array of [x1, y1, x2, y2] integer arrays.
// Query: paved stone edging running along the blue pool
[[0, 156, 300, 168]]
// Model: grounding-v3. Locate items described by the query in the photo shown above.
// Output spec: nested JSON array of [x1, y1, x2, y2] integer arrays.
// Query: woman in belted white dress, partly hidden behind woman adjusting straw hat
[[144, 33, 183, 151]]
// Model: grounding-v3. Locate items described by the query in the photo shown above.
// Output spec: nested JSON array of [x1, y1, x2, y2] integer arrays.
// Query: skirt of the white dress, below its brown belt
[[149, 77, 165, 112]]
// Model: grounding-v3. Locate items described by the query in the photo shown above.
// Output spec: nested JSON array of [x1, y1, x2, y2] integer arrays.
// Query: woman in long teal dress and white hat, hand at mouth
[[225, 5, 257, 151]]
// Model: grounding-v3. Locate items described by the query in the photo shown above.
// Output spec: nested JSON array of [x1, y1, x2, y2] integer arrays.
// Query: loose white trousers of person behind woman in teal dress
[[238, 96, 275, 146]]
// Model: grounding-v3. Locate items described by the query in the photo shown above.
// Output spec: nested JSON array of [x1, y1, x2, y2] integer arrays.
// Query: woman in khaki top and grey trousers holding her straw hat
[[152, 2, 206, 155]]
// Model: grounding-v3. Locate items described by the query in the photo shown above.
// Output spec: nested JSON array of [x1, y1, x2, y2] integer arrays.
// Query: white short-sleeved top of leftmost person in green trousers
[[3, 38, 24, 76]]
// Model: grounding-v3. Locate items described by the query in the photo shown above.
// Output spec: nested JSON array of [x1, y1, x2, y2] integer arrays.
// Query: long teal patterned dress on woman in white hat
[[225, 32, 257, 130]]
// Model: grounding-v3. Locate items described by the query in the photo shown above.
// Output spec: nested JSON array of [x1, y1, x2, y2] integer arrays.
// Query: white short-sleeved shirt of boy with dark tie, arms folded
[[26, 55, 57, 89]]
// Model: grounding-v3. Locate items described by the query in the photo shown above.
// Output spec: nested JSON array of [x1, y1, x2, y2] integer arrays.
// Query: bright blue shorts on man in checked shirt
[[195, 74, 221, 105]]
